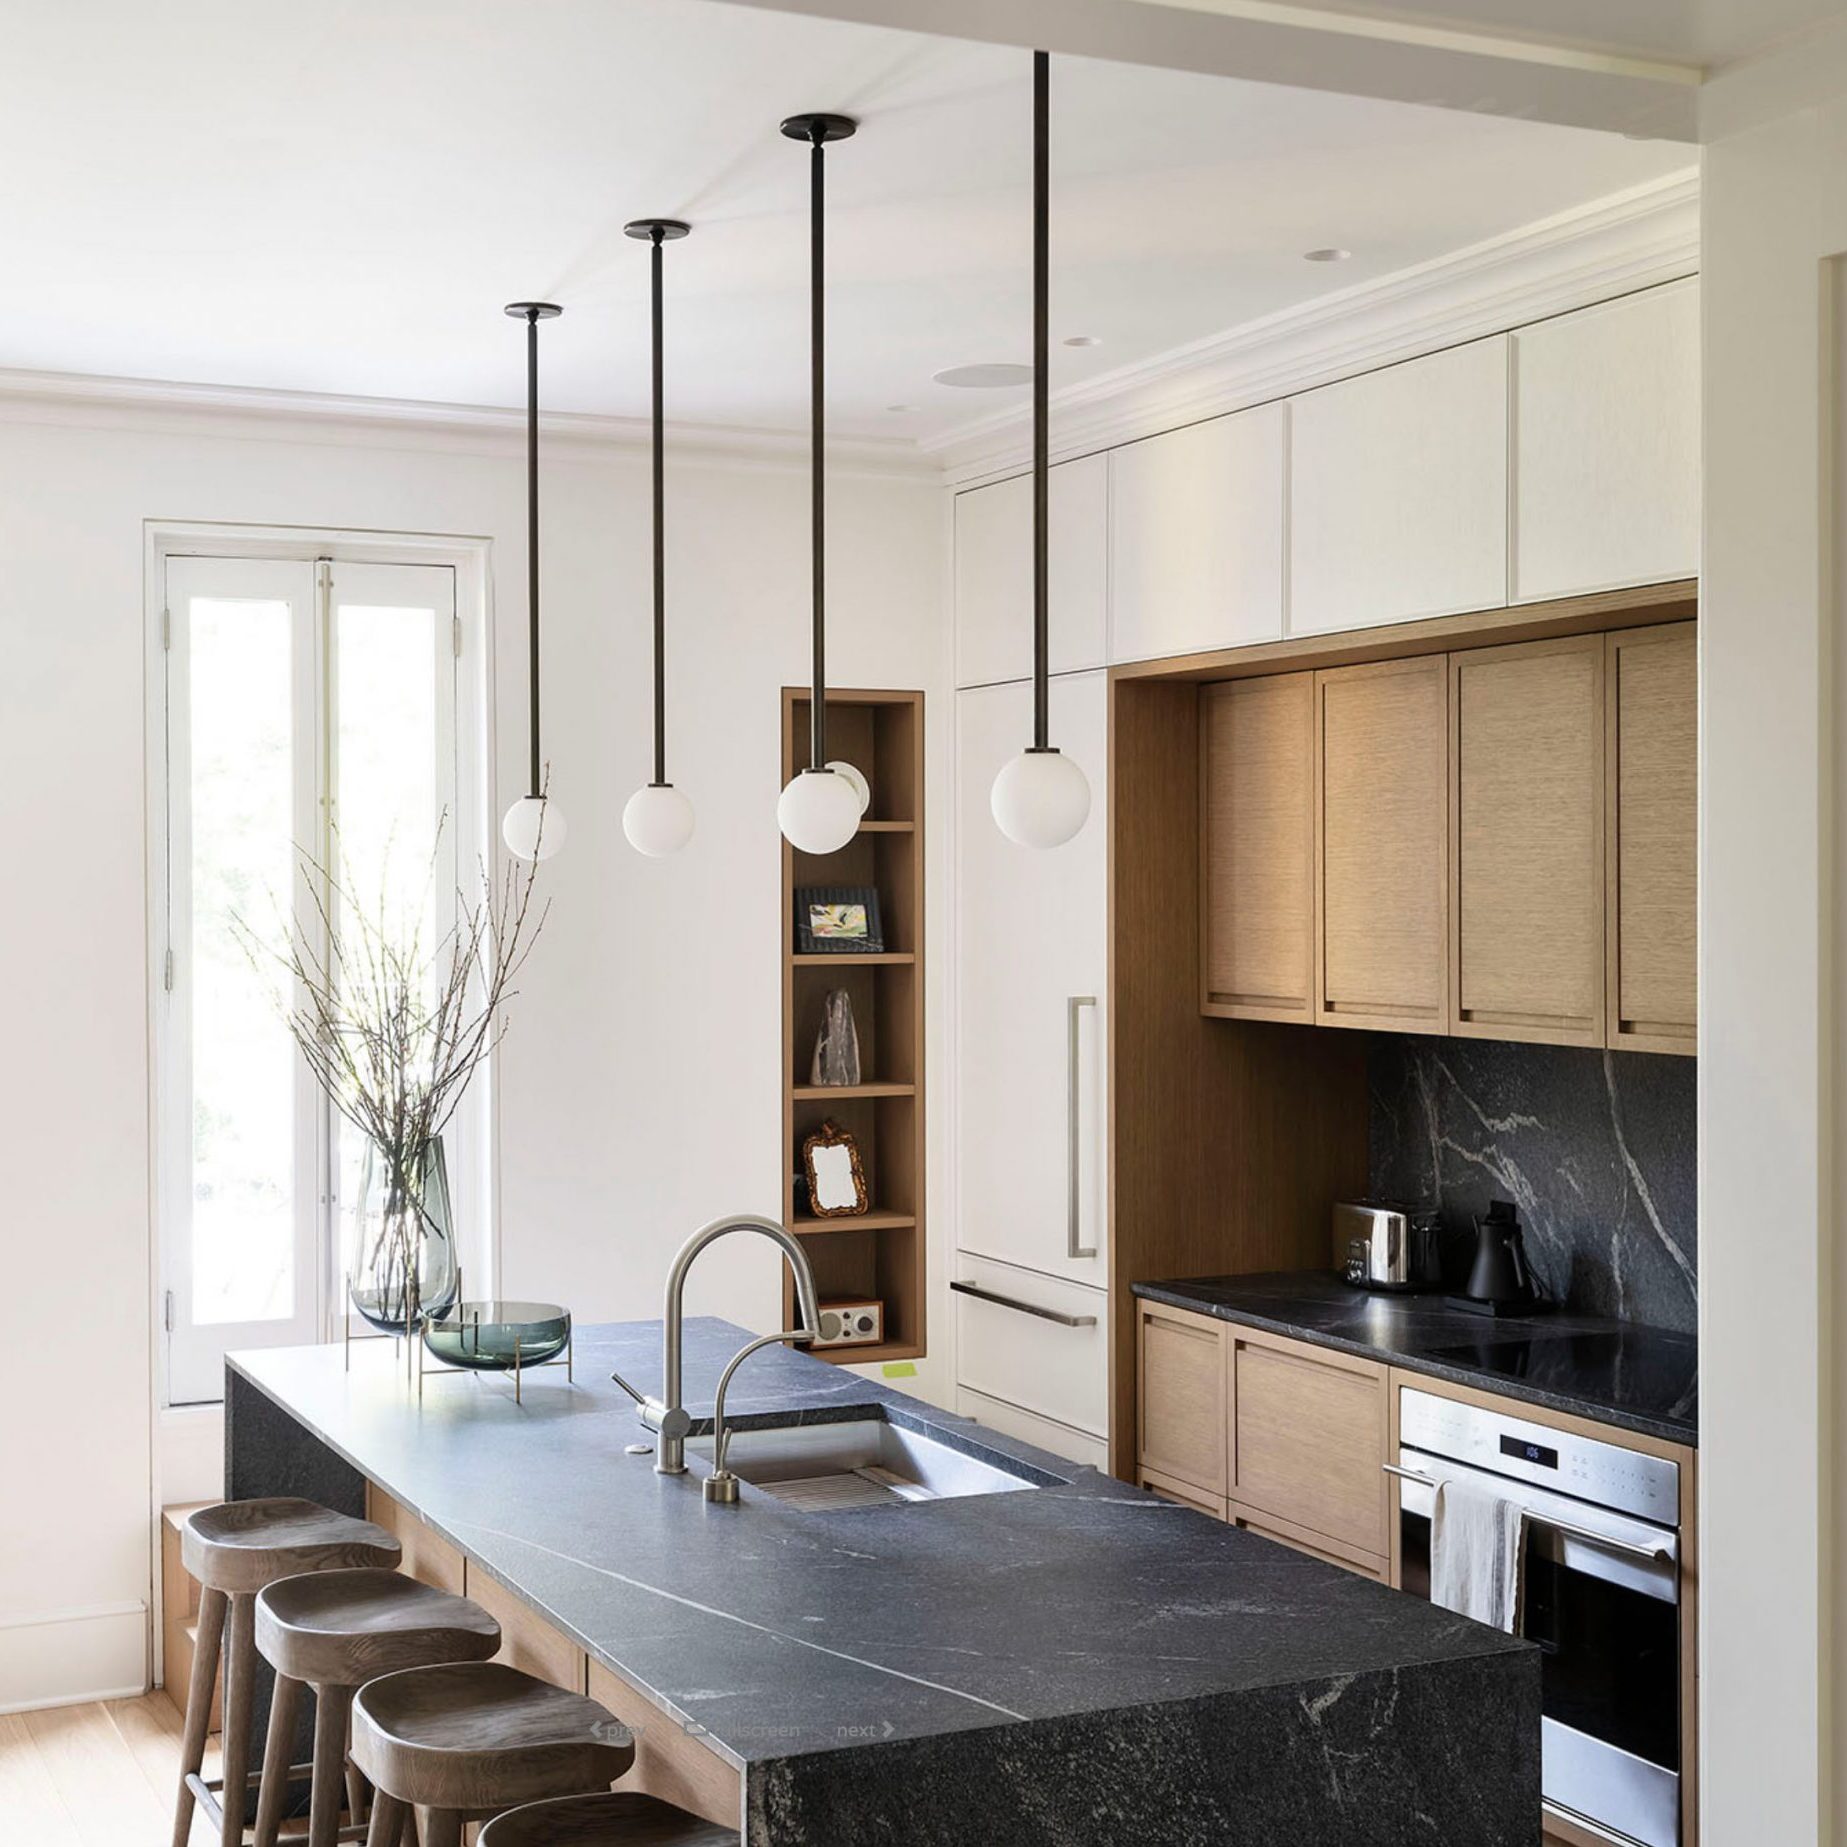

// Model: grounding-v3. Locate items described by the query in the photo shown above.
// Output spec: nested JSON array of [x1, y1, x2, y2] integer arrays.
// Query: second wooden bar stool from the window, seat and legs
[[257, 1566, 501, 1847]]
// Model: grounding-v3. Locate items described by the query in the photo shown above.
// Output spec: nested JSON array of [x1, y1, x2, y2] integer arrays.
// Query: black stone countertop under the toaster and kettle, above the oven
[[1134, 1271, 1699, 1444]]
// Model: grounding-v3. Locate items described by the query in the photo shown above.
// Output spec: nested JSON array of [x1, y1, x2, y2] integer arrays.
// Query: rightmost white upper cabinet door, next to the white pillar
[[1513, 281, 1699, 602]]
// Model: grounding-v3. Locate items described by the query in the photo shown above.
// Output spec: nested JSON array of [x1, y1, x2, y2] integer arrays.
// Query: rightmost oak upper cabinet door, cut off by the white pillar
[[1603, 622, 1699, 1053]]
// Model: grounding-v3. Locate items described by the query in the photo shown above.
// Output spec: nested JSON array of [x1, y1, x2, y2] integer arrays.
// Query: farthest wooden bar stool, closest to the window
[[174, 1498, 401, 1847]]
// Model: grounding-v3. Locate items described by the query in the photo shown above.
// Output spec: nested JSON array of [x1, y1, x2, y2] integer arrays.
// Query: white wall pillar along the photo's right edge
[[1699, 48, 1847, 1847]]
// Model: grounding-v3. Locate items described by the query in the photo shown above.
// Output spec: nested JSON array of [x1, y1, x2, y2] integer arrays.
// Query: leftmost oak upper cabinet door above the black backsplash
[[1199, 672, 1315, 1021]]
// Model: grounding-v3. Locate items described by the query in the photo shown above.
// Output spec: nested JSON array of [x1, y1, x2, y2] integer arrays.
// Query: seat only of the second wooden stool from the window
[[257, 1566, 501, 1686]]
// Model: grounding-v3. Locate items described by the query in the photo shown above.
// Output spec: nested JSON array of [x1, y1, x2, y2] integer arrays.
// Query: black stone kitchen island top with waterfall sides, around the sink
[[225, 1319, 1540, 1847]]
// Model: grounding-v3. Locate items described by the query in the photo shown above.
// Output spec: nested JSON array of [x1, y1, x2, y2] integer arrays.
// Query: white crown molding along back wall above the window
[[0, 368, 940, 480]]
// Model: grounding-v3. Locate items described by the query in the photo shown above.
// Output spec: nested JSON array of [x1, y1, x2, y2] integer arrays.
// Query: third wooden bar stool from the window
[[353, 1660, 635, 1847]]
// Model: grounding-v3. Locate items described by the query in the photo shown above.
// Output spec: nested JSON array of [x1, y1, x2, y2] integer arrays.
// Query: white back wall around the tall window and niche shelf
[[0, 406, 949, 1708]]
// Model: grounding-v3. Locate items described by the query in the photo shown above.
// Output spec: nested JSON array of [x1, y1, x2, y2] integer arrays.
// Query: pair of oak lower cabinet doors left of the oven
[[1136, 1302, 1391, 1581]]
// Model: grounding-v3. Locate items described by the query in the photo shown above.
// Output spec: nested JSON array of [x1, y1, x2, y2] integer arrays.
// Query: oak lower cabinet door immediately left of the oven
[[1225, 1328, 1391, 1577]]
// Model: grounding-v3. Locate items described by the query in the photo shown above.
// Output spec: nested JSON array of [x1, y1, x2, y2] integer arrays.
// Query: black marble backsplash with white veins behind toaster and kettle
[[1367, 1034, 1699, 1332]]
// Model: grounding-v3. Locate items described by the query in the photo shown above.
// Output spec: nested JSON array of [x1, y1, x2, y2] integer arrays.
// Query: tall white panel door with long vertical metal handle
[[955, 674, 1108, 1284]]
